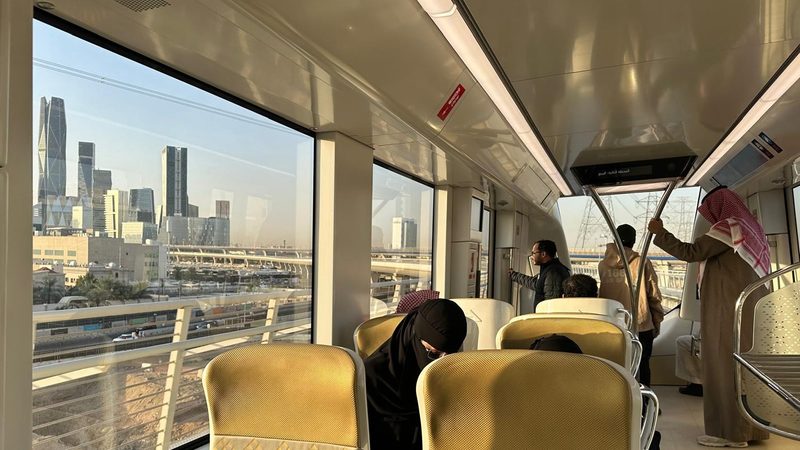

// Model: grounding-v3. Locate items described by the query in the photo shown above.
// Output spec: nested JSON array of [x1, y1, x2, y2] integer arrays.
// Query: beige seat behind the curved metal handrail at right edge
[[739, 283, 800, 436]]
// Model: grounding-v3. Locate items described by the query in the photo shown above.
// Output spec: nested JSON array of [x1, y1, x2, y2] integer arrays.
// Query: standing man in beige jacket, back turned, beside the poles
[[598, 224, 664, 386]]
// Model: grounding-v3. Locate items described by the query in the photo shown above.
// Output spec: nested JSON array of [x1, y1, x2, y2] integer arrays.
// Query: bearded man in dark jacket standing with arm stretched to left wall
[[509, 240, 569, 311]]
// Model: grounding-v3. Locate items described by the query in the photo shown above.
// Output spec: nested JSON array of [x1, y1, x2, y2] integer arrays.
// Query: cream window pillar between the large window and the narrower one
[[313, 133, 373, 348]]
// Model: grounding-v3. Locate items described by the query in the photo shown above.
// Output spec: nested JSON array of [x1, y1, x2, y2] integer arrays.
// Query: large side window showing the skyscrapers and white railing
[[32, 22, 314, 448]]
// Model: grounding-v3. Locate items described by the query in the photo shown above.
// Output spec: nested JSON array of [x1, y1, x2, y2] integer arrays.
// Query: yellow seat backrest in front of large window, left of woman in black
[[203, 343, 369, 450]]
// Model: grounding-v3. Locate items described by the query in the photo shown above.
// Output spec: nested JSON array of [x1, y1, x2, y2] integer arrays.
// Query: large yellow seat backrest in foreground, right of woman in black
[[417, 350, 642, 450]]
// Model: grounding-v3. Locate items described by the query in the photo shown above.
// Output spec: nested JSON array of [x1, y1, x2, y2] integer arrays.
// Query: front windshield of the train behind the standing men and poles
[[558, 188, 700, 310]]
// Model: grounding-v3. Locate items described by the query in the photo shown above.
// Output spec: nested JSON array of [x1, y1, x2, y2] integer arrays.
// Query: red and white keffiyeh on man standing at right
[[697, 188, 770, 277]]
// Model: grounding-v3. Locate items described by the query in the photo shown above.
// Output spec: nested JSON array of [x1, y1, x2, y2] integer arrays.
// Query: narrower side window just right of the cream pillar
[[370, 164, 433, 317]]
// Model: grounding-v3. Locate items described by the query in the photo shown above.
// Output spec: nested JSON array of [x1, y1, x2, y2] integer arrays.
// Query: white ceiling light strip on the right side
[[686, 52, 800, 185]]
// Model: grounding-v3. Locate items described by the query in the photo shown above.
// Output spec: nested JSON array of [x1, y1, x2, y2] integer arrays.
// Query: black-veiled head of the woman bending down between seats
[[414, 298, 467, 367]]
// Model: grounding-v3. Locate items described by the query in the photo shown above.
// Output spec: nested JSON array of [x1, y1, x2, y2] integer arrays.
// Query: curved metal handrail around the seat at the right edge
[[733, 263, 800, 440]]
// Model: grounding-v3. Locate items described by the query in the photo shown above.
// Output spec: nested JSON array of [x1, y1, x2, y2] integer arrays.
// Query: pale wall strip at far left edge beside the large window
[[0, 0, 33, 449]]
